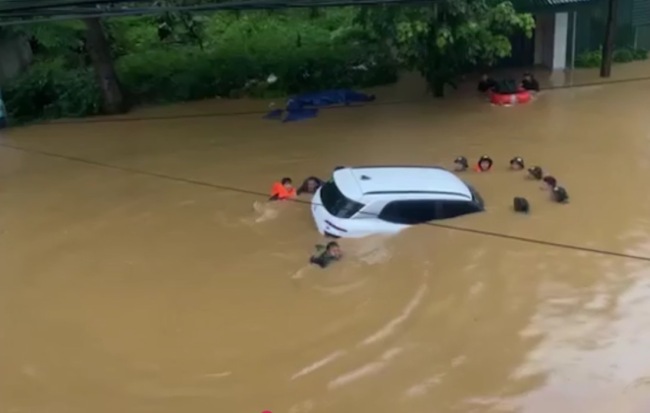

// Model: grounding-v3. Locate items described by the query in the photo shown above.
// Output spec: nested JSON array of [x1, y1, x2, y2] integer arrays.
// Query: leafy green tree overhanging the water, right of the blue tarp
[[358, 0, 535, 97]]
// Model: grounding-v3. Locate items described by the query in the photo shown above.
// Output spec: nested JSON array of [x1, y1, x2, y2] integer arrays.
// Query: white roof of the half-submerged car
[[333, 165, 472, 200]]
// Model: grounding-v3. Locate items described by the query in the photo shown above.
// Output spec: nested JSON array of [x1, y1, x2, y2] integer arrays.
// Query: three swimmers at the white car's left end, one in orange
[[269, 176, 343, 268]]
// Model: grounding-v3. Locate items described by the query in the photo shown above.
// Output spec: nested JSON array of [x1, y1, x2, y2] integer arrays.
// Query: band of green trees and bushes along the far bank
[[0, 0, 534, 122]]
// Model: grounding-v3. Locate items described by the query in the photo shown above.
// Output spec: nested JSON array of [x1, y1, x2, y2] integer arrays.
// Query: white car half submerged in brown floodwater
[[311, 166, 485, 238]]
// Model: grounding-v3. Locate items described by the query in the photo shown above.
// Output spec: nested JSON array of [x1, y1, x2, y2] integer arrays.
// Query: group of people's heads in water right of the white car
[[454, 155, 569, 209]]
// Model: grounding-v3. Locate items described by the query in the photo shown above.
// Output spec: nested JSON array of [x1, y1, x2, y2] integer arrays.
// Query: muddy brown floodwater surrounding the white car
[[0, 66, 650, 413]]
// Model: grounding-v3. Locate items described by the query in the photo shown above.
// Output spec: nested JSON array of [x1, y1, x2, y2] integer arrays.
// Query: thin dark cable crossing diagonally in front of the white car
[[0, 143, 650, 262]]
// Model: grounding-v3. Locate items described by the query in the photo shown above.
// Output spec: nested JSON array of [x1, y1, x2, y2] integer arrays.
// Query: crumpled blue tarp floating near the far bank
[[265, 89, 375, 122]]
